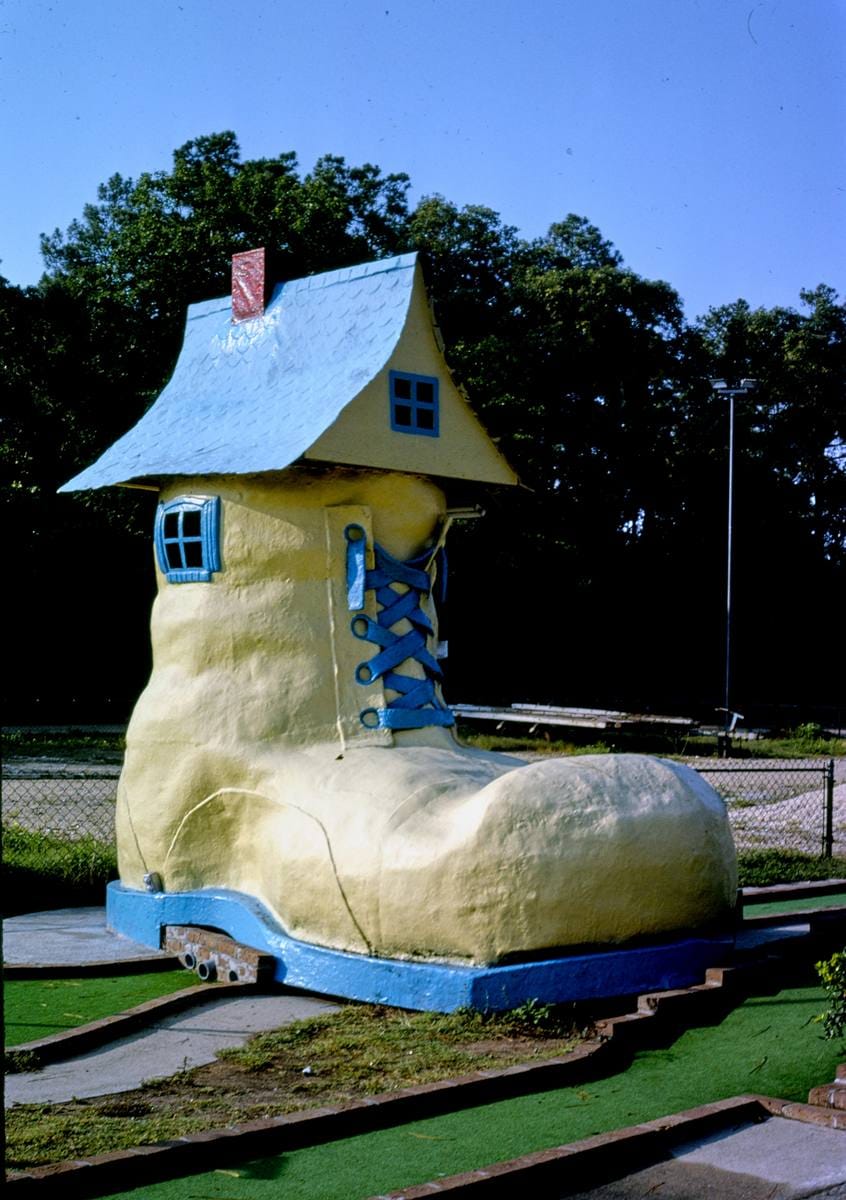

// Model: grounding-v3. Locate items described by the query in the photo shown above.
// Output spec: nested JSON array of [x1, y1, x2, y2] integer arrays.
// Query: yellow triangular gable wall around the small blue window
[[305, 266, 517, 484]]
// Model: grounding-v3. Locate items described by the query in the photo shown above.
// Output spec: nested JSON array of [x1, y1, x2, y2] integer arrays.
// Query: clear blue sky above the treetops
[[0, 0, 846, 318]]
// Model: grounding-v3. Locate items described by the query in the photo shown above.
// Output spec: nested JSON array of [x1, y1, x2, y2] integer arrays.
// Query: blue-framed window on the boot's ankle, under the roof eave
[[155, 496, 221, 583]]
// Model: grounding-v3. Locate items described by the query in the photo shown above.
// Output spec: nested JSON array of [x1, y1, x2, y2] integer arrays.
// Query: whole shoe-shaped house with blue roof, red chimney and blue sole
[[64, 252, 736, 1009]]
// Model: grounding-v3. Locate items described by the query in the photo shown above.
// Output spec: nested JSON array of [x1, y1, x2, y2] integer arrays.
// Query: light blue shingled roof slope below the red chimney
[[60, 254, 416, 492]]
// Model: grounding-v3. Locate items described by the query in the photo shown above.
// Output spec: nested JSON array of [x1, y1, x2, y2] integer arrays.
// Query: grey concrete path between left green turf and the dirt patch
[[6, 992, 337, 1106]]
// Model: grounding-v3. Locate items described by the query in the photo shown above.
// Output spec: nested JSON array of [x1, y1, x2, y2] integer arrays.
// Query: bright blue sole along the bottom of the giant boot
[[106, 883, 733, 1013]]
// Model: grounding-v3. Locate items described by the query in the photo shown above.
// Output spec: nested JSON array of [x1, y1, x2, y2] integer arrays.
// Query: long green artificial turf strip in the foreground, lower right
[[100, 988, 846, 1200]]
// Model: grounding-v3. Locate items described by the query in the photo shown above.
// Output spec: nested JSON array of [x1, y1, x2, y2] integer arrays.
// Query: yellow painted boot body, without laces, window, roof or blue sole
[[118, 460, 736, 964]]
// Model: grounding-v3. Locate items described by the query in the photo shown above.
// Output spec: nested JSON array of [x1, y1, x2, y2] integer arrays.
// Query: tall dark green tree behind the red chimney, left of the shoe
[[6, 133, 407, 720]]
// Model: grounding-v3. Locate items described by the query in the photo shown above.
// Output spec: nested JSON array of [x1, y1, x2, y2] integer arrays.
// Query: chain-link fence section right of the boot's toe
[[690, 758, 846, 858]]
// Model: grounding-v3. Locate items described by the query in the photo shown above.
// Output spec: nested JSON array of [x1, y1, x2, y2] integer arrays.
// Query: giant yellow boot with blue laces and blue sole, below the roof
[[62, 248, 736, 1008]]
